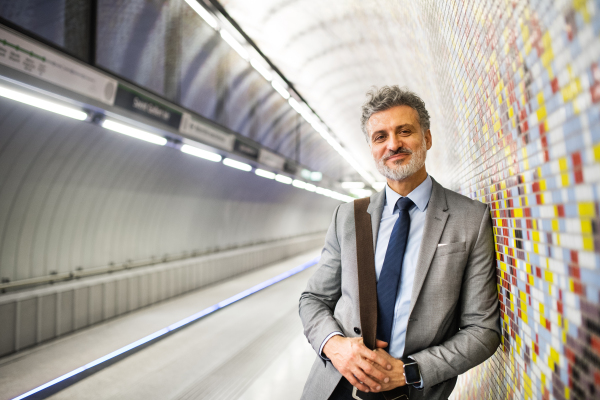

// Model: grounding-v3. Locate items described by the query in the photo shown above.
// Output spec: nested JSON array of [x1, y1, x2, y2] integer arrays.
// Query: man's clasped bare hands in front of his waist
[[323, 335, 406, 392]]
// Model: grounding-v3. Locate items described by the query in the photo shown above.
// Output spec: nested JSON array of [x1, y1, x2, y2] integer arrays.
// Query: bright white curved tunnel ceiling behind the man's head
[[221, 0, 446, 184]]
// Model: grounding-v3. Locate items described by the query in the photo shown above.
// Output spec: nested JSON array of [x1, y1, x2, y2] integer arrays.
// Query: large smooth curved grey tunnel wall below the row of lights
[[0, 99, 338, 284]]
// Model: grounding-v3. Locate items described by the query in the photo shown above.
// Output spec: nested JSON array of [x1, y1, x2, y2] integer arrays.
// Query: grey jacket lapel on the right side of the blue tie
[[408, 178, 448, 315]]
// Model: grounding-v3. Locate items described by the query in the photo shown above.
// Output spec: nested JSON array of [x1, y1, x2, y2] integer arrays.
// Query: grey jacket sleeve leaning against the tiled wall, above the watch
[[410, 206, 501, 388]]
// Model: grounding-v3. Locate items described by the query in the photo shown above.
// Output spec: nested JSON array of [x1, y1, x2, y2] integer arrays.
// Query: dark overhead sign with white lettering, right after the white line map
[[115, 84, 182, 129]]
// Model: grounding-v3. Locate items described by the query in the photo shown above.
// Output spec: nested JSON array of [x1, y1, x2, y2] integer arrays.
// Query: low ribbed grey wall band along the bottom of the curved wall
[[0, 233, 324, 357]]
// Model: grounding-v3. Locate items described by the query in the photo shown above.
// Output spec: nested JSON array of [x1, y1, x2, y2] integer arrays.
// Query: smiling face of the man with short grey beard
[[367, 106, 431, 181]]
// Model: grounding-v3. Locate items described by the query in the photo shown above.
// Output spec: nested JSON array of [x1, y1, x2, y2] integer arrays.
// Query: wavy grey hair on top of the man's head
[[360, 85, 429, 142]]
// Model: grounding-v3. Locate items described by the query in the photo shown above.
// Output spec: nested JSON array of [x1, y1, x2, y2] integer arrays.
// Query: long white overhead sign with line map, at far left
[[0, 26, 117, 105]]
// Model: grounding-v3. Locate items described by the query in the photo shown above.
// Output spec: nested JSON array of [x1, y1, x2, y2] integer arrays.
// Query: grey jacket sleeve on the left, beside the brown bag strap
[[299, 206, 342, 354]]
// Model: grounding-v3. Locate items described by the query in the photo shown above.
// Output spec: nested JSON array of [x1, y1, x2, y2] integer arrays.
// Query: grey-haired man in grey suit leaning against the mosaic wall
[[300, 86, 501, 400]]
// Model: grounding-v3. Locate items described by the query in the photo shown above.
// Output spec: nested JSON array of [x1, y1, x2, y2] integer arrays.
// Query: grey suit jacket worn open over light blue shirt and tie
[[300, 180, 501, 400]]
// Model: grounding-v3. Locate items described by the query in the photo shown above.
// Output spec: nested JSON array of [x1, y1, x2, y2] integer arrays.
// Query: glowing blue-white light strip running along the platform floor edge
[[12, 256, 320, 400]]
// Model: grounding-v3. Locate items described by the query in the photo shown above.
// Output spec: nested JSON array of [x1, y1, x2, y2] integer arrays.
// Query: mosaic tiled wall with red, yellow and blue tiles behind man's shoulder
[[418, 0, 600, 399]]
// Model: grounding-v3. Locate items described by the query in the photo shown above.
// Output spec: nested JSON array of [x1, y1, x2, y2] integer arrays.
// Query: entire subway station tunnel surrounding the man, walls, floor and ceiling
[[0, 0, 600, 400]]
